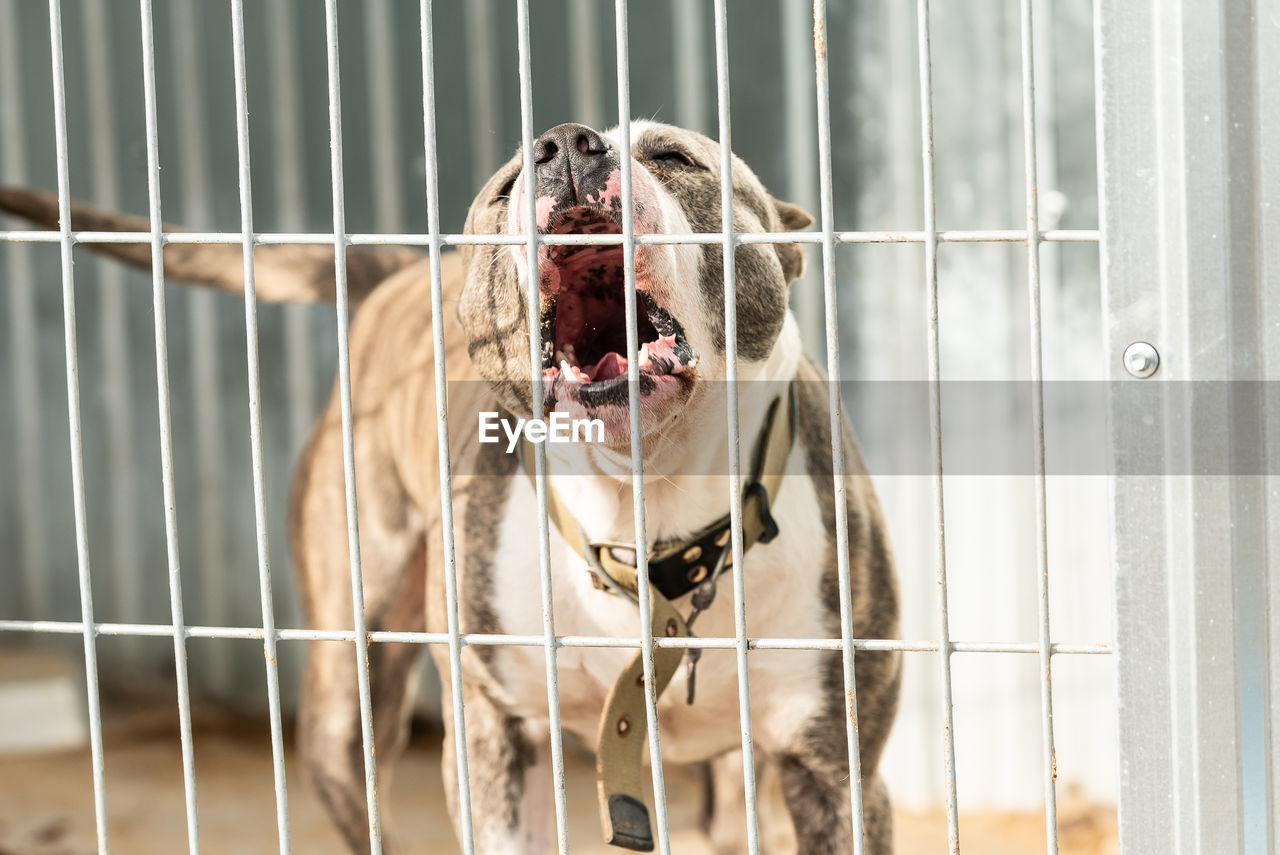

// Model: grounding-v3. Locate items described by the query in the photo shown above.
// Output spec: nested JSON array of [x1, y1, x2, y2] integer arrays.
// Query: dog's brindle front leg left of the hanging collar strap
[[442, 689, 553, 855]]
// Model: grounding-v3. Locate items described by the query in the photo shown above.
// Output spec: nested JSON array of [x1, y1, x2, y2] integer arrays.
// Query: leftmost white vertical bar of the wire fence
[[49, 0, 110, 855]]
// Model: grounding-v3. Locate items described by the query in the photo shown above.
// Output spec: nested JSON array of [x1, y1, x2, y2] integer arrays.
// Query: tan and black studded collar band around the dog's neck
[[521, 381, 796, 600]]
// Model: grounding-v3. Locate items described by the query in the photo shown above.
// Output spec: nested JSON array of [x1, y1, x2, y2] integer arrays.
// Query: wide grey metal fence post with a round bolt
[[1096, 0, 1280, 855]]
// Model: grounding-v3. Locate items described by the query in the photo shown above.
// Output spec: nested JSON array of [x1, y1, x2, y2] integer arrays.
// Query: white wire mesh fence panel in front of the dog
[[0, 0, 1121, 855]]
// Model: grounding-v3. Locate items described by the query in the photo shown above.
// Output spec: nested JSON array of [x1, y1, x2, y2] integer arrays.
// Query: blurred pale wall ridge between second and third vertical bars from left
[[168, 0, 233, 689]]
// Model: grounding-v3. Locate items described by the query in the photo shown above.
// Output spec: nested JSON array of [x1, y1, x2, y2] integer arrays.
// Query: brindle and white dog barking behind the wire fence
[[0, 122, 900, 855]]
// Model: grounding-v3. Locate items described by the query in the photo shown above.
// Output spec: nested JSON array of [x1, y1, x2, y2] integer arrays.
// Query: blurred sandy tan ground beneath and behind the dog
[[0, 709, 1116, 855]]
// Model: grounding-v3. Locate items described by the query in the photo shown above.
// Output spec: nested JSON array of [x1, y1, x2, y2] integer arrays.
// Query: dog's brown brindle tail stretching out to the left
[[0, 187, 422, 302]]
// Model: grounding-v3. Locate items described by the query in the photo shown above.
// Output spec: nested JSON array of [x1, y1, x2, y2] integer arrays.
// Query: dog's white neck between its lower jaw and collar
[[548, 314, 801, 547]]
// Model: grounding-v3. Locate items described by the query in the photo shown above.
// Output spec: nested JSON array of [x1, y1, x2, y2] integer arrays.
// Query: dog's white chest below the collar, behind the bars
[[478, 468, 835, 762]]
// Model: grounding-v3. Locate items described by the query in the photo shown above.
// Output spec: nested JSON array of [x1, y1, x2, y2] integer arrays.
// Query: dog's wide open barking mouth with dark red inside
[[539, 207, 696, 410]]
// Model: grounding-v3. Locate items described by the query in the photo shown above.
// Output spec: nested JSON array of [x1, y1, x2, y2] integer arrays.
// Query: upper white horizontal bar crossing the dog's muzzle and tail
[[0, 229, 1098, 246]]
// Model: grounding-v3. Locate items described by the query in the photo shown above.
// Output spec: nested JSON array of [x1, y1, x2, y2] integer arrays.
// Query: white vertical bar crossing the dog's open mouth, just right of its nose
[[613, 0, 671, 855]]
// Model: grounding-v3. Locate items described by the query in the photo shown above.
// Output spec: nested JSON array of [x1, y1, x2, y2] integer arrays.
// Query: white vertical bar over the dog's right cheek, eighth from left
[[716, 0, 760, 855]]
